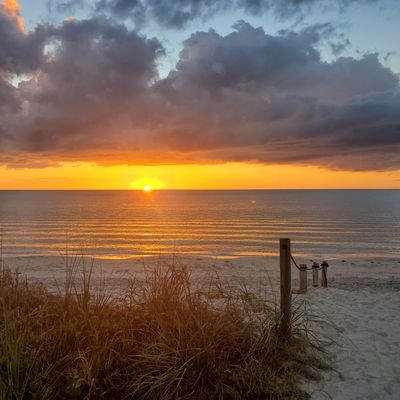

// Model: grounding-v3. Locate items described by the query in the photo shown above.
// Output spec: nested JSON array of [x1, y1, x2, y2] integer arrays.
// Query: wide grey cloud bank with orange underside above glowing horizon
[[0, 1, 400, 170]]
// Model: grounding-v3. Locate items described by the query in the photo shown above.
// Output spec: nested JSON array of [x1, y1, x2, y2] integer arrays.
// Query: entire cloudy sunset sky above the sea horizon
[[0, 0, 400, 190]]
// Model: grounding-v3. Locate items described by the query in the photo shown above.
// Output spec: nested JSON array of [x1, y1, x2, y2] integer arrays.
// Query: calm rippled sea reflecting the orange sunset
[[0, 190, 400, 258]]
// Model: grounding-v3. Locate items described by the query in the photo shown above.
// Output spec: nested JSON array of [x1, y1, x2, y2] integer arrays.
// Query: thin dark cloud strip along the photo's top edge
[[96, 0, 378, 28]]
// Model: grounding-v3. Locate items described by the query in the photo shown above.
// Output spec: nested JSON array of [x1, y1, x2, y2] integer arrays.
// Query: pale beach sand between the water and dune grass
[[6, 256, 400, 400]]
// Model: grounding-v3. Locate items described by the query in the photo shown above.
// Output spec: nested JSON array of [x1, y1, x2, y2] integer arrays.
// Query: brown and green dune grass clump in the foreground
[[0, 265, 328, 400]]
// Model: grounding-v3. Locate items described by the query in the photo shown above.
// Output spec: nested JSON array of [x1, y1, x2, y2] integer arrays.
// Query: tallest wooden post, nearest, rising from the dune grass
[[279, 239, 292, 336]]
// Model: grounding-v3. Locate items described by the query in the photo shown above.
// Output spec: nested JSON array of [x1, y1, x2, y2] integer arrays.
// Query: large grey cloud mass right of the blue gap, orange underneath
[[148, 22, 400, 169]]
